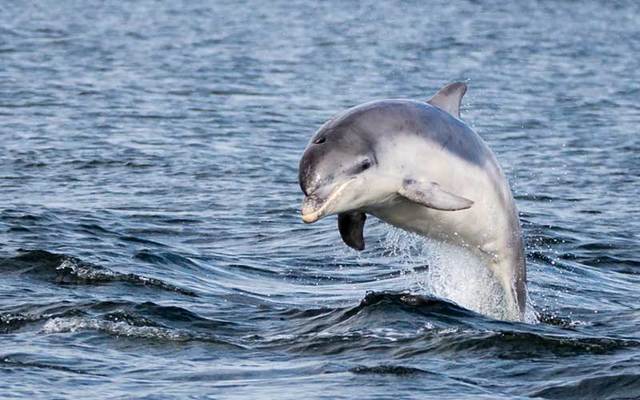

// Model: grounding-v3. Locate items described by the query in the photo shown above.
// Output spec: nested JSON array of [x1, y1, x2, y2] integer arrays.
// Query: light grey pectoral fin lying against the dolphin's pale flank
[[398, 179, 473, 211]]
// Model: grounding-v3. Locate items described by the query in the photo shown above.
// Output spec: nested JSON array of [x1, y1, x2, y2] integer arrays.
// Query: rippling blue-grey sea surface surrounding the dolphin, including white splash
[[0, 0, 640, 399]]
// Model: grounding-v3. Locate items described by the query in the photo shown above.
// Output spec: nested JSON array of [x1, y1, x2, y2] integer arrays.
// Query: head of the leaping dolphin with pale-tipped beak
[[298, 119, 392, 223]]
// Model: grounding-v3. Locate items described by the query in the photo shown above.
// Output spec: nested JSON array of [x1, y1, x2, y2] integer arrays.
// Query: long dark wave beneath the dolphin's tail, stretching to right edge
[[263, 292, 640, 359]]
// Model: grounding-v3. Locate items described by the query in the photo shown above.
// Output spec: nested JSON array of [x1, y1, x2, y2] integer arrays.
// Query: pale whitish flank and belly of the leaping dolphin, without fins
[[366, 137, 524, 320]]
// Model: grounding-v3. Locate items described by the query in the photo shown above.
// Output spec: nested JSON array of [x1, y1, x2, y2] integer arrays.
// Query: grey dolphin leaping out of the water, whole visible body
[[298, 82, 527, 321]]
